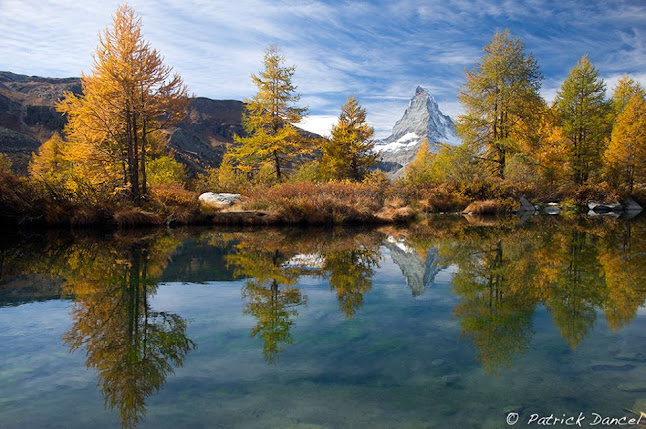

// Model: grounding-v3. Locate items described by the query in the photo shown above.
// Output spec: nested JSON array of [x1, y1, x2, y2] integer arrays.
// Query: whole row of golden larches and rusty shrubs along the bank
[[0, 5, 646, 226]]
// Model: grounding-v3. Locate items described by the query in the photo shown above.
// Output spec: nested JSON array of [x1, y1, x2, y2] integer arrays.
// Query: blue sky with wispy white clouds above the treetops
[[0, 0, 646, 137]]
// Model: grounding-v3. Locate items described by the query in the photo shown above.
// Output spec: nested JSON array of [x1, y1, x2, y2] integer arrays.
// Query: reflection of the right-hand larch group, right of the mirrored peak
[[404, 218, 646, 372]]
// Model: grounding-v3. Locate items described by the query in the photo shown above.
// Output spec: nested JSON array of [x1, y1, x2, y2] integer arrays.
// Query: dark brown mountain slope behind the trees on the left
[[0, 72, 319, 176]]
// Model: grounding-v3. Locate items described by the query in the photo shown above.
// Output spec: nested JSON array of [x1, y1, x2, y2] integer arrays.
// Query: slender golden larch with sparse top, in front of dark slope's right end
[[230, 45, 311, 180]]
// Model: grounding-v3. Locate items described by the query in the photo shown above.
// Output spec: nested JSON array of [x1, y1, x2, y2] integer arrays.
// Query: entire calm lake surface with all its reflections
[[0, 216, 646, 429]]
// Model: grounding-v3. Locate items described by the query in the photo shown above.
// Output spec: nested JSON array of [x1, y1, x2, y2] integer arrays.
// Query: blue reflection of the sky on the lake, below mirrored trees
[[0, 254, 646, 428]]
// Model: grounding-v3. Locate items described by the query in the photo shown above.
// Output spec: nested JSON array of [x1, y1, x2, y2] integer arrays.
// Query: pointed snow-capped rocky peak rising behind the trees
[[375, 86, 460, 172]]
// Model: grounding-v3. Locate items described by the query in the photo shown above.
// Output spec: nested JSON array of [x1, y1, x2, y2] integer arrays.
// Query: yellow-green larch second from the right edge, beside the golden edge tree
[[555, 55, 610, 185]]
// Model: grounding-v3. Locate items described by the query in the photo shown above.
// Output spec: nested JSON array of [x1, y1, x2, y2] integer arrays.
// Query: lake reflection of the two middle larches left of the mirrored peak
[[224, 230, 380, 363]]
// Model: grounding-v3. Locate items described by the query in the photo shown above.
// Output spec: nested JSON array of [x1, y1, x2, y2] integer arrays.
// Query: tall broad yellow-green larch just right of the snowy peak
[[457, 30, 543, 177]]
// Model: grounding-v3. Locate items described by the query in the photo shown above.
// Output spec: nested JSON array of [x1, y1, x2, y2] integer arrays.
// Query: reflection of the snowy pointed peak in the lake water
[[385, 237, 443, 296]]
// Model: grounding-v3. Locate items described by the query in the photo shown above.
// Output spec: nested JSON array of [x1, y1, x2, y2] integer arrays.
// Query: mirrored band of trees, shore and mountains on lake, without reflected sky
[[0, 217, 646, 427]]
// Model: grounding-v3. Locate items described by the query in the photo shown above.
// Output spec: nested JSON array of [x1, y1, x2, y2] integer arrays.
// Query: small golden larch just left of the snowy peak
[[320, 96, 379, 180]]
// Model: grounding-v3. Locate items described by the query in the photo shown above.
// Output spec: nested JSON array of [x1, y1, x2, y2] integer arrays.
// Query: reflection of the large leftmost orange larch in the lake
[[52, 234, 195, 427]]
